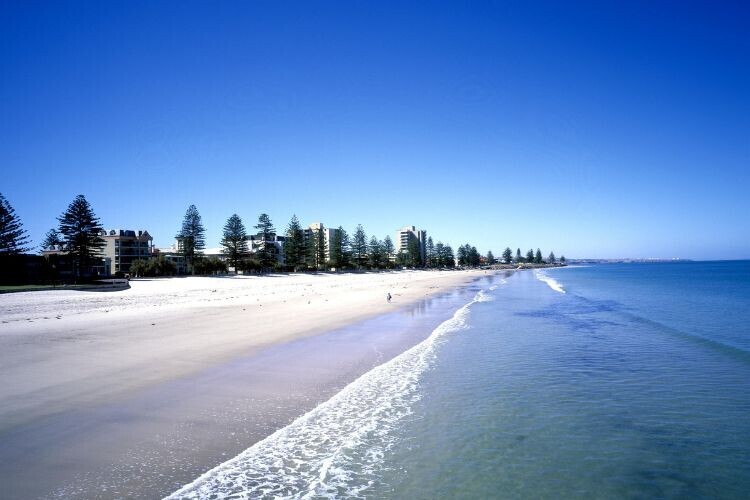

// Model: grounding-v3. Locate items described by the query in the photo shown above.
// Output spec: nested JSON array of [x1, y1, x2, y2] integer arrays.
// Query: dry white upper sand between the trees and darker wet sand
[[0, 271, 483, 431]]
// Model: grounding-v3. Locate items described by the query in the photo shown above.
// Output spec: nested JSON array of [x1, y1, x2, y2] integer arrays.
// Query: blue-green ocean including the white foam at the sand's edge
[[171, 261, 750, 499]]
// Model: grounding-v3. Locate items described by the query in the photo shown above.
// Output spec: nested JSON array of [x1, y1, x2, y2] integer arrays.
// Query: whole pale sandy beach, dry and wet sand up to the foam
[[0, 271, 485, 498]]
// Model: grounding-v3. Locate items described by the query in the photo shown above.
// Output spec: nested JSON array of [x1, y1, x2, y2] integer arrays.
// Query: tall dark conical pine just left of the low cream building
[[57, 194, 104, 277]]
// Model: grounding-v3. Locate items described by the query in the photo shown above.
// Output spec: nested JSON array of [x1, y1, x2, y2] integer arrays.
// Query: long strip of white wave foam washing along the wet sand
[[167, 292, 488, 499]]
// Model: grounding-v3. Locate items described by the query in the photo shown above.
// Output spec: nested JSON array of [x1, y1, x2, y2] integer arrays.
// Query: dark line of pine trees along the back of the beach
[[0, 194, 565, 279]]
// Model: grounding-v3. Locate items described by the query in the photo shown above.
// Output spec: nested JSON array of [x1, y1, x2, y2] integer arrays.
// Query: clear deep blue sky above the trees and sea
[[0, 1, 750, 259]]
